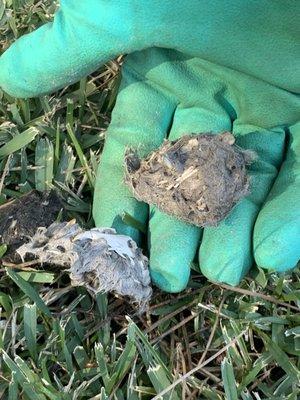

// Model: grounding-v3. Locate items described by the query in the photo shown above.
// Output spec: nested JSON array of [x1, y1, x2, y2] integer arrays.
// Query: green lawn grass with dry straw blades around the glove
[[0, 0, 300, 400]]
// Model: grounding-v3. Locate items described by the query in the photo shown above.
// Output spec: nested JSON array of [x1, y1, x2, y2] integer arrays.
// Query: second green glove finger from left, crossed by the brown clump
[[148, 103, 231, 292]]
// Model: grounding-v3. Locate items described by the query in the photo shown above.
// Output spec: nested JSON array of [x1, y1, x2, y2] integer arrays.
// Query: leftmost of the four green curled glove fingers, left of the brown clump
[[93, 60, 175, 241]]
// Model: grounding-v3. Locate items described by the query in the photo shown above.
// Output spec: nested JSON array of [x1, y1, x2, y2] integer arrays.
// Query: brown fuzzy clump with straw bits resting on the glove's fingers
[[125, 132, 255, 226]]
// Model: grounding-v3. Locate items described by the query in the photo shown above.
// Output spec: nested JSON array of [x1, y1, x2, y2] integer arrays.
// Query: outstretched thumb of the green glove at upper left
[[0, 0, 137, 97]]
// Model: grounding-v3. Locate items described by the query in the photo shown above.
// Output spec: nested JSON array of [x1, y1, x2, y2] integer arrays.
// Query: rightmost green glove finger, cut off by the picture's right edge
[[254, 122, 300, 272]]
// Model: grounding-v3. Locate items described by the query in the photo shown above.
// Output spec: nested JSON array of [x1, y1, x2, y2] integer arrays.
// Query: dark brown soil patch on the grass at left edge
[[0, 190, 63, 258]]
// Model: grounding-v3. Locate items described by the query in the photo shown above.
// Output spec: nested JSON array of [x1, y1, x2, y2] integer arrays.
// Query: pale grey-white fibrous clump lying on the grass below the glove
[[17, 220, 152, 310]]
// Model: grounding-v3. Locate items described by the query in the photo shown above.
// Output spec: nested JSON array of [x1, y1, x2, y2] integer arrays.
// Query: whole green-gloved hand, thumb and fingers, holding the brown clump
[[0, 0, 300, 292]]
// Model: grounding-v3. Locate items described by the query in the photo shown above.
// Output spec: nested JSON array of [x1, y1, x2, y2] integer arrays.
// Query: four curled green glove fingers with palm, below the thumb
[[94, 49, 300, 291]]
